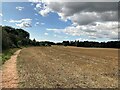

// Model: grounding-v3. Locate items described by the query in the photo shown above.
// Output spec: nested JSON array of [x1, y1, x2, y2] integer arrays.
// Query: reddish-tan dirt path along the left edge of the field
[[2, 50, 21, 88]]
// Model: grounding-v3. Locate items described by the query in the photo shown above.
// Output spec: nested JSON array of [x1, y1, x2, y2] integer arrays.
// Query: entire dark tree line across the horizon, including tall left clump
[[0, 26, 120, 50]]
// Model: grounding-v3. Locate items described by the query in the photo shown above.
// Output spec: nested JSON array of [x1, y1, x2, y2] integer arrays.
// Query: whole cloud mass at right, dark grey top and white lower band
[[36, 2, 118, 39]]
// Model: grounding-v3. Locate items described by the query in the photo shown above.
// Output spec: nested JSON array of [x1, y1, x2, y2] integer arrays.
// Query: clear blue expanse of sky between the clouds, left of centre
[[2, 2, 74, 41]]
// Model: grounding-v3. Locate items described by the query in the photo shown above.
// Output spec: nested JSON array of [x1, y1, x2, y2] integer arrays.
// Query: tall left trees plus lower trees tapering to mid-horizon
[[0, 26, 55, 50]]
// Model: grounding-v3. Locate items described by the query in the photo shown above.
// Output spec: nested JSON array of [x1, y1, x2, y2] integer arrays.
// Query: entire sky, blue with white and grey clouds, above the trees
[[0, 2, 118, 42]]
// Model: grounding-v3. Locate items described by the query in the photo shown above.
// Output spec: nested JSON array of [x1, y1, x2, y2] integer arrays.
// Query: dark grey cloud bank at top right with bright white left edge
[[36, 1, 118, 24]]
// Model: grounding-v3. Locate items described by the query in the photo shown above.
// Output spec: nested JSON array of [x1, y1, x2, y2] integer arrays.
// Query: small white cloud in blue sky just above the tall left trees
[[9, 18, 32, 28]]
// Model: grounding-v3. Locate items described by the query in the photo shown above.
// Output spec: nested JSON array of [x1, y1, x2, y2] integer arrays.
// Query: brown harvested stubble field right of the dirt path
[[17, 46, 118, 88]]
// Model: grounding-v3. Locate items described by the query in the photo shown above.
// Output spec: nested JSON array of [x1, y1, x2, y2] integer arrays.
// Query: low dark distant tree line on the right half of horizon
[[62, 40, 120, 48]]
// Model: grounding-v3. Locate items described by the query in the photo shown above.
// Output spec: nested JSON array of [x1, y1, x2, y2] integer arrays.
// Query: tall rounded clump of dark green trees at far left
[[2, 26, 29, 50]]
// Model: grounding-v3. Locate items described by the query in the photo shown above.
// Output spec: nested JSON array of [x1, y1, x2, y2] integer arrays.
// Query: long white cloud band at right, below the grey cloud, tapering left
[[46, 22, 118, 39]]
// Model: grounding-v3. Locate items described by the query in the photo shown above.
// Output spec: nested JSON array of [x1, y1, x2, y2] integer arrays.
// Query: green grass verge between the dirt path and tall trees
[[0, 48, 19, 64]]
